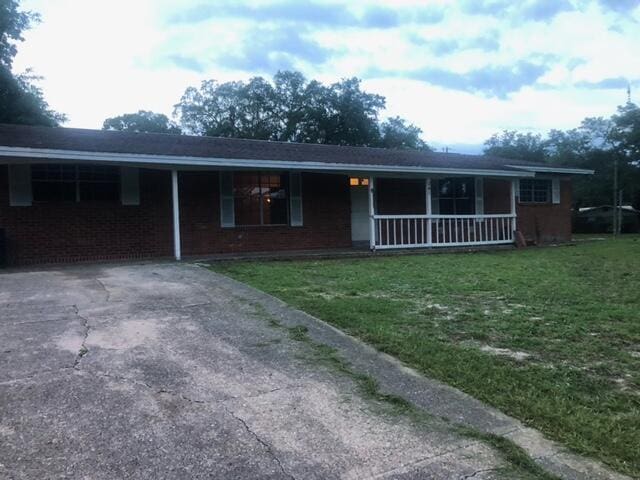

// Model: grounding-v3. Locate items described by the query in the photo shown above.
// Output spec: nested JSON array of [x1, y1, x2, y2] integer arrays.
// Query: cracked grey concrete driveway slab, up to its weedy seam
[[0, 264, 524, 479]]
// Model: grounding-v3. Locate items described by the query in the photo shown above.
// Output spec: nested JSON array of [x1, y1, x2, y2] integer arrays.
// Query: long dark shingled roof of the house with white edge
[[0, 124, 593, 176]]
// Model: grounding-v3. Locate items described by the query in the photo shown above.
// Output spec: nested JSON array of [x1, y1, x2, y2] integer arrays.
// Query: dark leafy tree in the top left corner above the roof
[[0, 0, 66, 126]]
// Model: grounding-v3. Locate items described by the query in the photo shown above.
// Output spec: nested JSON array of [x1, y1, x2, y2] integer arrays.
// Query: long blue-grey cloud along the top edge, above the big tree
[[168, 0, 444, 29]]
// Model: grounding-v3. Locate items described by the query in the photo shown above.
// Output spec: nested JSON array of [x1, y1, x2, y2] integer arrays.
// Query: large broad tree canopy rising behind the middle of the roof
[[174, 71, 428, 149]]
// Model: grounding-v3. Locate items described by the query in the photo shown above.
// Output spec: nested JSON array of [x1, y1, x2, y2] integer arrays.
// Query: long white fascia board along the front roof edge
[[0, 146, 535, 177]]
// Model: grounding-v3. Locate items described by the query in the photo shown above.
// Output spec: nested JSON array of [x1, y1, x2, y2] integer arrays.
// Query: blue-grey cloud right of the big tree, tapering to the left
[[370, 60, 549, 99]]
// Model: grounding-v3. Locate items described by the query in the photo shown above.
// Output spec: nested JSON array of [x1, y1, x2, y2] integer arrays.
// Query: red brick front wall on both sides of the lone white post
[[0, 166, 351, 265]]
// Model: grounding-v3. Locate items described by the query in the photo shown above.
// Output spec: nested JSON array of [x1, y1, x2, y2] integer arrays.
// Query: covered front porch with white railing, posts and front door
[[350, 176, 518, 250]]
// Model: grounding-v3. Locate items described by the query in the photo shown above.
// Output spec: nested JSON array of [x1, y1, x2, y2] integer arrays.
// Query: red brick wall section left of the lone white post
[[0, 165, 173, 265]]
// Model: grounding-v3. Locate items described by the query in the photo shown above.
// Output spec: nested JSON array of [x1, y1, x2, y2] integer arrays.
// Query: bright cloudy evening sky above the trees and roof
[[14, 0, 640, 153]]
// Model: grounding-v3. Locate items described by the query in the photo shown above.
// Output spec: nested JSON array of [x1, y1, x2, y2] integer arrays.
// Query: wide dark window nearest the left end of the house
[[31, 164, 120, 202]]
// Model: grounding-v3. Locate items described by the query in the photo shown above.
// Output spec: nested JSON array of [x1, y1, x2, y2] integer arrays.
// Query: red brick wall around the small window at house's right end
[[516, 180, 571, 243]]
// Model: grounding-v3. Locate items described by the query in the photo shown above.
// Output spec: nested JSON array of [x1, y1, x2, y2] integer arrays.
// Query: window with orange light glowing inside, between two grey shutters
[[233, 172, 289, 225]]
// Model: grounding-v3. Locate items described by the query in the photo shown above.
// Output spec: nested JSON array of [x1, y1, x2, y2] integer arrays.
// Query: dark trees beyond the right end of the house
[[484, 101, 640, 208]]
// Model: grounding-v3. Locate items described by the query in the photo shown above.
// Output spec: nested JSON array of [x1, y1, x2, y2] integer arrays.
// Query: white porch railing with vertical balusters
[[371, 214, 516, 249]]
